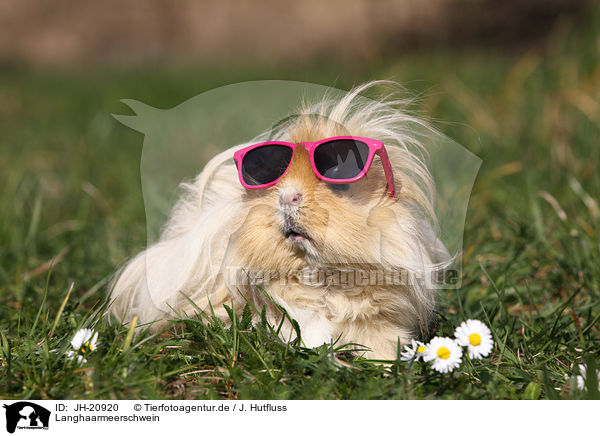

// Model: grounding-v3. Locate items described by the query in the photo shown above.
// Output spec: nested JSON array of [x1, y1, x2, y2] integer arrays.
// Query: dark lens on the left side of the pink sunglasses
[[242, 144, 293, 185]]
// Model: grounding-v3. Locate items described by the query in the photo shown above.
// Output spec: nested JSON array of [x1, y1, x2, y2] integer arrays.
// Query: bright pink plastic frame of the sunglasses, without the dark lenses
[[233, 136, 396, 198]]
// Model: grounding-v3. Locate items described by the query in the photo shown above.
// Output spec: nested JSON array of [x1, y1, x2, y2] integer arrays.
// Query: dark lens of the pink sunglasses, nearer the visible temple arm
[[315, 139, 369, 179]]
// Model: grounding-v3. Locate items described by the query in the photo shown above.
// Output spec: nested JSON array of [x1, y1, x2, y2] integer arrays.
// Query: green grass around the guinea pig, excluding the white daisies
[[0, 11, 600, 399]]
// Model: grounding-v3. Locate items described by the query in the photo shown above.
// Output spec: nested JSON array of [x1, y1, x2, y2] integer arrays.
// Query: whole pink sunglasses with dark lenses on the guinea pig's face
[[233, 136, 396, 198]]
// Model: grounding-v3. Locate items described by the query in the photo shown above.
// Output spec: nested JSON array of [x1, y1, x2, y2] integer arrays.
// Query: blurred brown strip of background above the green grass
[[0, 0, 589, 67]]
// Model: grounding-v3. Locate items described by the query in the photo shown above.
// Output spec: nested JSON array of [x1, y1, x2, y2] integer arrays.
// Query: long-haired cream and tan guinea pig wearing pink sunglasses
[[110, 83, 449, 359]]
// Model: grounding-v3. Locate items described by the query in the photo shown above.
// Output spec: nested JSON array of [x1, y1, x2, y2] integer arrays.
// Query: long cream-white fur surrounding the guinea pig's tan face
[[110, 82, 450, 358]]
